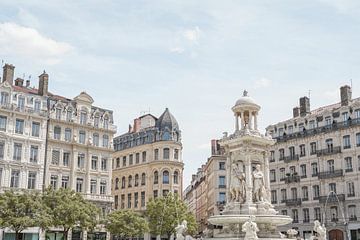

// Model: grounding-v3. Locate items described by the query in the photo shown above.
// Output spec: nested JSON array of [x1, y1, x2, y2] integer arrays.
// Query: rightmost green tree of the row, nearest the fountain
[[146, 193, 197, 239]]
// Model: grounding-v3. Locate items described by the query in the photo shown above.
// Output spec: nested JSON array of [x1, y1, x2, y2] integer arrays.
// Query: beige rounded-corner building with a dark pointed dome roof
[[112, 109, 184, 217]]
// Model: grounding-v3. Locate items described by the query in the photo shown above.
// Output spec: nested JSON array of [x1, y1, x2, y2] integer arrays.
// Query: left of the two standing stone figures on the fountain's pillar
[[230, 163, 246, 203]]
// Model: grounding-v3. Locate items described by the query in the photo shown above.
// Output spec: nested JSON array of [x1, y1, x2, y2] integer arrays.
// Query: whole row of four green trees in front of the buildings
[[0, 188, 196, 240]]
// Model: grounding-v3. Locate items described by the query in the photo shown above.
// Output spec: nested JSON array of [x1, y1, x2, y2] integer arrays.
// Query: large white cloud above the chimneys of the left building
[[0, 22, 73, 64]]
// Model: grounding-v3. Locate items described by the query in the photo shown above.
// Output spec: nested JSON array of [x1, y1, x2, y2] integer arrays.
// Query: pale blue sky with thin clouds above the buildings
[[0, 0, 360, 188]]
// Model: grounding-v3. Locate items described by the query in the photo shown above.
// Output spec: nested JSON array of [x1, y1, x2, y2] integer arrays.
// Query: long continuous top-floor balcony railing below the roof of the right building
[[274, 118, 360, 142]]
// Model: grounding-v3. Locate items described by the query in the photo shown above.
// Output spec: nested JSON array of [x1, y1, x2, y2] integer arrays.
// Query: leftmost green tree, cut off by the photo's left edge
[[0, 190, 50, 240]]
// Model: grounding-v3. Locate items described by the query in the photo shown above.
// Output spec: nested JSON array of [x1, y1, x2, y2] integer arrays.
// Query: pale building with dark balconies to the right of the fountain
[[267, 86, 360, 240]]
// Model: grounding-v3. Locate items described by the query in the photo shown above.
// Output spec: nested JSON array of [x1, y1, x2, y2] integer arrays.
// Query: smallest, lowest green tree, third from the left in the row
[[105, 210, 149, 238]]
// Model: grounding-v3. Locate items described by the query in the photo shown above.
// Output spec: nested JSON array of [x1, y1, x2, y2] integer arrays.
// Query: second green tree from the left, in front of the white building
[[43, 188, 99, 240]]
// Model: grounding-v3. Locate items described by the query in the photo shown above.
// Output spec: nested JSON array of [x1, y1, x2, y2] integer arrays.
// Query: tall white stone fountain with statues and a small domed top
[[208, 91, 292, 240]]
